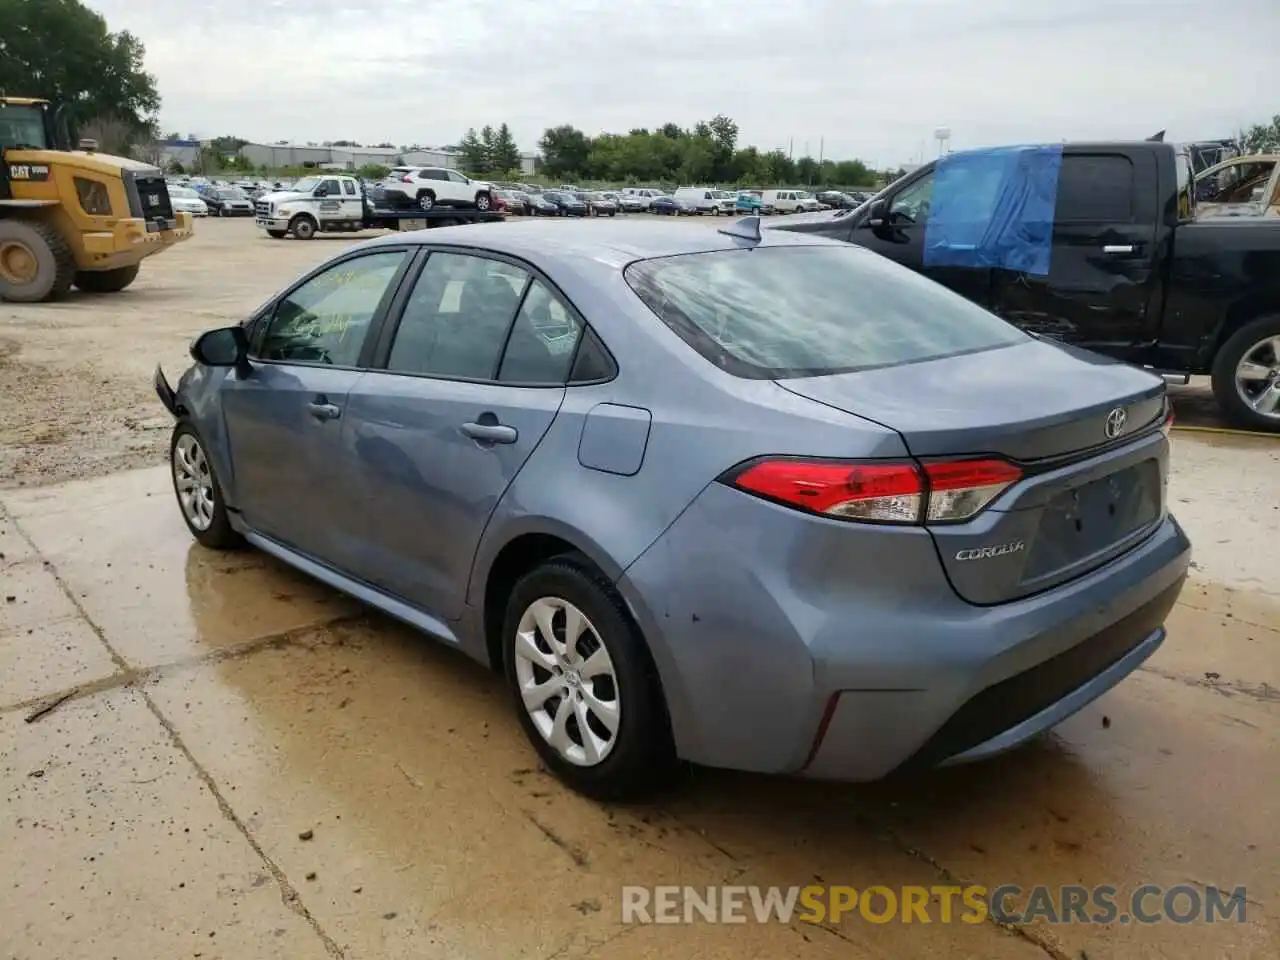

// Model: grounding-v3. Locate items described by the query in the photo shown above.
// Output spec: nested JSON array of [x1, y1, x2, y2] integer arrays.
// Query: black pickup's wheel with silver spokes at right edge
[[1213, 315, 1280, 433]]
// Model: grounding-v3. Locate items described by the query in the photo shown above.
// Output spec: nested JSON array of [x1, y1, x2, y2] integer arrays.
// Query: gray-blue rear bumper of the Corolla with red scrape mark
[[618, 484, 1190, 780]]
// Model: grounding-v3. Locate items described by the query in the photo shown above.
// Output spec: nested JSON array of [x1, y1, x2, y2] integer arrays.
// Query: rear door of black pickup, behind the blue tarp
[[995, 148, 1164, 360]]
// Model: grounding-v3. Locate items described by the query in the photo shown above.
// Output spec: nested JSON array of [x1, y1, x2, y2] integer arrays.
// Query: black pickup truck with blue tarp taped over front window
[[769, 141, 1280, 433]]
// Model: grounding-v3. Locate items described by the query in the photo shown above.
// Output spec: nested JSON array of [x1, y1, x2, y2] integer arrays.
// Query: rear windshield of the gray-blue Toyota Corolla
[[625, 246, 1027, 379]]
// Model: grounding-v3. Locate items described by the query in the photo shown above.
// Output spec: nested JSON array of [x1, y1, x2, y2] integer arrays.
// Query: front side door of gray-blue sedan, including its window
[[220, 248, 408, 558]]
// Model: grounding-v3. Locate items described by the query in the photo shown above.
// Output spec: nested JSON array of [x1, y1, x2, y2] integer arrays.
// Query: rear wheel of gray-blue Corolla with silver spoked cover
[[502, 554, 677, 800]]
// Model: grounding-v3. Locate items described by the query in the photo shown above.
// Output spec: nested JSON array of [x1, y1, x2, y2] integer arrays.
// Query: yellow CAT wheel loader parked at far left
[[0, 96, 192, 303]]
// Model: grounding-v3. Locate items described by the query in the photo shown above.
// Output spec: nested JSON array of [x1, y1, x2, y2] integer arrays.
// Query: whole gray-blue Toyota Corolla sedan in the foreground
[[156, 219, 1190, 797]]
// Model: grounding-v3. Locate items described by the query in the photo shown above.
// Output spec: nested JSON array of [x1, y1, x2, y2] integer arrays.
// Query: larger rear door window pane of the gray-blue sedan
[[387, 253, 529, 380]]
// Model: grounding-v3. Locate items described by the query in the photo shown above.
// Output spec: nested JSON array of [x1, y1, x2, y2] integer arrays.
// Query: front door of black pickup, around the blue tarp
[[849, 169, 993, 308]]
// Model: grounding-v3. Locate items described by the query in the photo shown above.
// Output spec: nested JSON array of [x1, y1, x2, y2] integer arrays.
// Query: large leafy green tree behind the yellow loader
[[0, 0, 160, 136]]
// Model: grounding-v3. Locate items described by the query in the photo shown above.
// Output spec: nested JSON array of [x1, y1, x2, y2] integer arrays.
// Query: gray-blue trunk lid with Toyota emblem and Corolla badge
[[777, 340, 1169, 604]]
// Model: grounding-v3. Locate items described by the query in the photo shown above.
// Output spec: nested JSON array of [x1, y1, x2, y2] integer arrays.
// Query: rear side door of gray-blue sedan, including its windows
[[343, 250, 582, 620]]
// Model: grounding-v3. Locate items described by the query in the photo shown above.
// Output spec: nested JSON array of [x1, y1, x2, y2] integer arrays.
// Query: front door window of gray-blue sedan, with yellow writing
[[256, 250, 406, 366]]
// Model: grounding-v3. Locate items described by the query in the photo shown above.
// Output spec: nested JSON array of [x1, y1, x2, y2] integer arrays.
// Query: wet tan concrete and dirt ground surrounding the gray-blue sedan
[[0, 220, 1280, 960]]
